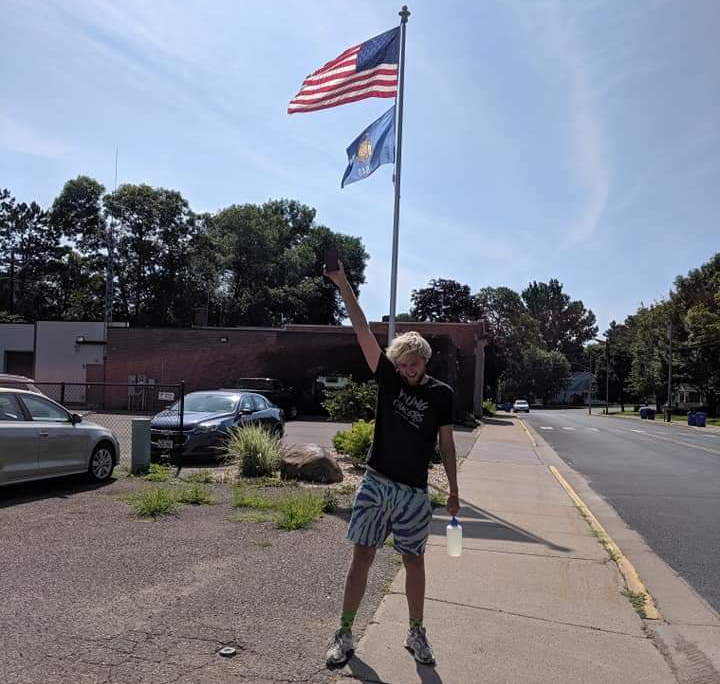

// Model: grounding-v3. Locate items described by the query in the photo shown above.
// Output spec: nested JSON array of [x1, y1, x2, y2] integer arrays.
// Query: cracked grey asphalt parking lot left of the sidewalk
[[0, 422, 474, 684]]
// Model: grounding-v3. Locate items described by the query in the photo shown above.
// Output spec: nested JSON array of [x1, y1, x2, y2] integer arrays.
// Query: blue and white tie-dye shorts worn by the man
[[347, 471, 432, 556]]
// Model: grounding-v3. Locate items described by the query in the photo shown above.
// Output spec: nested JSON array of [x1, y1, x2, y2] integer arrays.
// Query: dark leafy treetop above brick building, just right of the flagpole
[[410, 278, 482, 323]]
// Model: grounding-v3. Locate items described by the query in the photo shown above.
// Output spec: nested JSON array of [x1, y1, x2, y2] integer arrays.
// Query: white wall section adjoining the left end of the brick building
[[35, 321, 105, 382]]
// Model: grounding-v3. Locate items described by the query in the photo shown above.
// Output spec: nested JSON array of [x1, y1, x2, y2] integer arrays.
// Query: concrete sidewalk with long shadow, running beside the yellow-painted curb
[[340, 418, 676, 684]]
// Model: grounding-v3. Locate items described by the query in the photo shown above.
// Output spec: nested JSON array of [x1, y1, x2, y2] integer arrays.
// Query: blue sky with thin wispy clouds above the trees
[[0, 0, 720, 331]]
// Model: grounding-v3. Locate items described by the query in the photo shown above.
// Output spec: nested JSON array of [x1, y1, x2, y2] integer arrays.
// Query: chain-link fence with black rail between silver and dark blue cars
[[34, 382, 185, 468]]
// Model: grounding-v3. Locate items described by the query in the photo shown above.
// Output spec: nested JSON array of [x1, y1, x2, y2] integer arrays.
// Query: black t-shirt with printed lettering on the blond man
[[368, 354, 453, 489]]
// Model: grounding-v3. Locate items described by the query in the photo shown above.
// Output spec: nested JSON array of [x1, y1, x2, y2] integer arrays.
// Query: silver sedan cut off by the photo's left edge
[[0, 388, 120, 486]]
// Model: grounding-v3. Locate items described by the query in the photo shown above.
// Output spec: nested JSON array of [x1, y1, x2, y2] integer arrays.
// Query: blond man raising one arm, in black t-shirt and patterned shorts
[[325, 264, 459, 666]]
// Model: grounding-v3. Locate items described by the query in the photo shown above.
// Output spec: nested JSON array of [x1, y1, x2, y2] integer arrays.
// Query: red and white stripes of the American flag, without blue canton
[[288, 44, 398, 114]]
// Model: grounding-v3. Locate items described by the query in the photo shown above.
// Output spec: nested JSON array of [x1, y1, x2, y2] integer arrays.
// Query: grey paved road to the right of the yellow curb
[[516, 410, 720, 612]]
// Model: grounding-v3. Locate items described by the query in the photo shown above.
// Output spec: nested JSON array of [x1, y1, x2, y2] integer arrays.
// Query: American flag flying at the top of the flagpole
[[288, 27, 400, 114]]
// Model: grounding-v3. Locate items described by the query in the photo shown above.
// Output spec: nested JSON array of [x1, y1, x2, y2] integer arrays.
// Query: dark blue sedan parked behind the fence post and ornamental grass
[[150, 390, 285, 456]]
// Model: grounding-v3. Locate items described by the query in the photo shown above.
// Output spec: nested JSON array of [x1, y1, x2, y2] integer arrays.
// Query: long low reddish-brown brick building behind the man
[[104, 322, 485, 417]]
